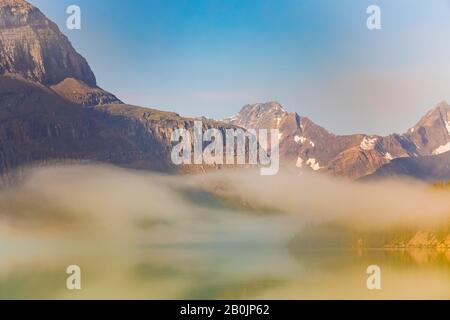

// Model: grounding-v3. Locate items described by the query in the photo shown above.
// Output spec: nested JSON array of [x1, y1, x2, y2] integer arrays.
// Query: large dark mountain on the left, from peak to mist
[[0, 0, 237, 177]]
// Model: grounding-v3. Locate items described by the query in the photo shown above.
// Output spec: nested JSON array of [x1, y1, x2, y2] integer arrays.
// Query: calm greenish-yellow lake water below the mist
[[0, 245, 450, 299]]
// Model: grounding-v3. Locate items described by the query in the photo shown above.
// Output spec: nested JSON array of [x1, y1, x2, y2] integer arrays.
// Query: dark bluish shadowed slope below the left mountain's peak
[[0, 77, 175, 172]]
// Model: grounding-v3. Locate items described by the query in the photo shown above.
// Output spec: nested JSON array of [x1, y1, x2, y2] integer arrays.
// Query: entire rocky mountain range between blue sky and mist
[[0, 0, 450, 180]]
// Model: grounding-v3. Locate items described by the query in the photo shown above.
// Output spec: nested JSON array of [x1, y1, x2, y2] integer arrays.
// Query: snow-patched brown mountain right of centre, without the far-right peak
[[224, 102, 422, 179]]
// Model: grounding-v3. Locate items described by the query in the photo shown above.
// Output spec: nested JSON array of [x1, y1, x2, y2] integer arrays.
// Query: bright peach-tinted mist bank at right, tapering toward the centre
[[192, 171, 450, 229]]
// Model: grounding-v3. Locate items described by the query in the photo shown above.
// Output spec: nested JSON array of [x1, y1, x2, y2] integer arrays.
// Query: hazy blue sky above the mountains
[[30, 0, 450, 134]]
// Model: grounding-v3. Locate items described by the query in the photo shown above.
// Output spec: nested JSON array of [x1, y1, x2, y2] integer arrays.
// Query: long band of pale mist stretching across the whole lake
[[0, 165, 450, 245]]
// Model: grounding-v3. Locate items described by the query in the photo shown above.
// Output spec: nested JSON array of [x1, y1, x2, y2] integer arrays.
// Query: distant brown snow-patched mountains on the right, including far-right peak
[[224, 102, 450, 179]]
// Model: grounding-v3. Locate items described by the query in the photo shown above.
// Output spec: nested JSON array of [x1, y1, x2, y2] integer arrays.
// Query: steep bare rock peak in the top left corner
[[0, 0, 96, 87]]
